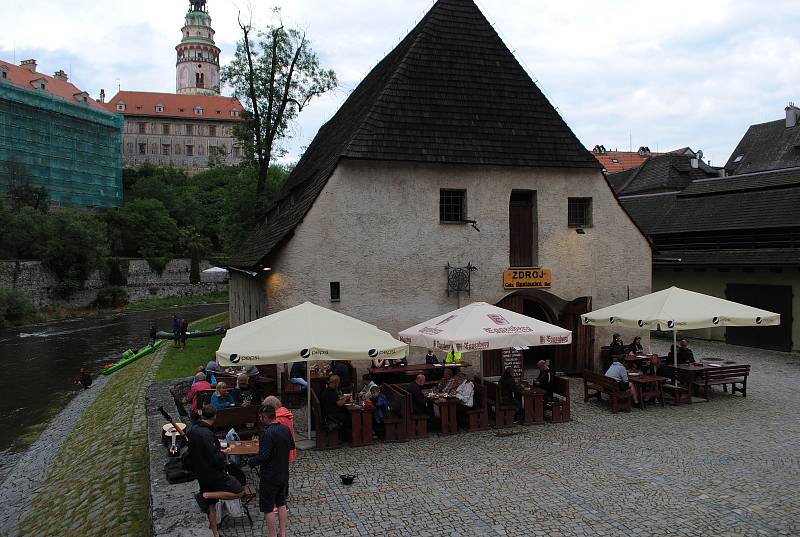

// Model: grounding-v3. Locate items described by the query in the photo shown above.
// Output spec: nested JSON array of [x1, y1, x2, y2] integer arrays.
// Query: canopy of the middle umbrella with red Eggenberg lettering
[[399, 302, 572, 352]]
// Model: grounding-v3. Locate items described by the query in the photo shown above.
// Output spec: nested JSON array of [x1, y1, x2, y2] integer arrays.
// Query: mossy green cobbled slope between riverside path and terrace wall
[[19, 352, 161, 537]]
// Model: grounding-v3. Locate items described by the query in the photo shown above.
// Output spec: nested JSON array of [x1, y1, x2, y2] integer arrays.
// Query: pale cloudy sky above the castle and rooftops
[[0, 0, 800, 165]]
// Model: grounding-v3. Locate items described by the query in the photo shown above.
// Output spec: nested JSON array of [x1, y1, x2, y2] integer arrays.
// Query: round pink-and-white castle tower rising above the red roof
[[175, 0, 220, 95]]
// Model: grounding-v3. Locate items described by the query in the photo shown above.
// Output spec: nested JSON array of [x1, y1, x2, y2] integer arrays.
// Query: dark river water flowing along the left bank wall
[[0, 304, 227, 458]]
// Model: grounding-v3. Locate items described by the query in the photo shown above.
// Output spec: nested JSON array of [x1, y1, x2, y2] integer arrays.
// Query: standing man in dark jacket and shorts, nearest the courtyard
[[249, 405, 294, 537]]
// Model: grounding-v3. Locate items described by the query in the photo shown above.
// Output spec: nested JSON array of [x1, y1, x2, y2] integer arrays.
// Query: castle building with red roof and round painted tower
[[103, 0, 242, 172]]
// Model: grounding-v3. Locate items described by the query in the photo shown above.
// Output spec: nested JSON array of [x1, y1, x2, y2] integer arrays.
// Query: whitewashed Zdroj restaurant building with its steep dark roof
[[229, 0, 651, 375]]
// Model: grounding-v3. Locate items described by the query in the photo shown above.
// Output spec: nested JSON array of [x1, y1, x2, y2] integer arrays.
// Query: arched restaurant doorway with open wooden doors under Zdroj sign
[[482, 289, 594, 377]]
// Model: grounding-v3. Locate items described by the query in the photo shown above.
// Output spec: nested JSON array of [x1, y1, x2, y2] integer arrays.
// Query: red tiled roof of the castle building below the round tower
[[105, 91, 243, 121]]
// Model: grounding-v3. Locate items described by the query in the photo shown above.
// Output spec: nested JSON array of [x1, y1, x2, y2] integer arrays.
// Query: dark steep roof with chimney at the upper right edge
[[725, 119, 800, 175]]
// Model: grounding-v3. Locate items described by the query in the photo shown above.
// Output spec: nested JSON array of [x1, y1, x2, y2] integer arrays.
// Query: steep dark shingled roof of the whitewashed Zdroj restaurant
[[231, 0, 600, 267]]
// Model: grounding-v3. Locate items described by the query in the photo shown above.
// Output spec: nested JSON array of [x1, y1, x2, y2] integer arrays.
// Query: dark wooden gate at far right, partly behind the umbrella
[[725, 283, 793, 351]]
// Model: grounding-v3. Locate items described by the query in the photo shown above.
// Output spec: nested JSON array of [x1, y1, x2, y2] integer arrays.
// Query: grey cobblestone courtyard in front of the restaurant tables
[[208, 341, 800, 537]]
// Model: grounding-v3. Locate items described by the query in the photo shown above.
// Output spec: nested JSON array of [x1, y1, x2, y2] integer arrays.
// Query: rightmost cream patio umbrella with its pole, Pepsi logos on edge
[[581, 287, 781, 365]]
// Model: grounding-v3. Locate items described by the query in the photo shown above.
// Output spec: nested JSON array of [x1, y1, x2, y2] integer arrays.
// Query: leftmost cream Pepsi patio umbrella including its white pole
[[216, 302, 408, 446]]
